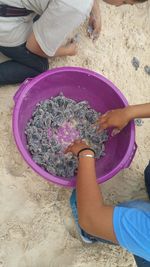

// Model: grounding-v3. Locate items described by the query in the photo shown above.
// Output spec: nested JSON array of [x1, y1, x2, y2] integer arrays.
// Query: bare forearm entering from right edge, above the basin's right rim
[[127, 103, 150, 120]]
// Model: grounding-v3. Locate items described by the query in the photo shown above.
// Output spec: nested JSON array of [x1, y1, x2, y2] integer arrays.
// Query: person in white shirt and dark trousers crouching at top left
[[0, 0, 100, 85]]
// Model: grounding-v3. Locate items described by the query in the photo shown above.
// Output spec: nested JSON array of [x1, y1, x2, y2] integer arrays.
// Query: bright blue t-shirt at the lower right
[[113, 200, 150, 261]]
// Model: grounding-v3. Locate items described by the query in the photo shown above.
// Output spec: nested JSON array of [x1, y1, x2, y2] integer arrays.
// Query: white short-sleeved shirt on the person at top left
[[0, 0, 93, 56]]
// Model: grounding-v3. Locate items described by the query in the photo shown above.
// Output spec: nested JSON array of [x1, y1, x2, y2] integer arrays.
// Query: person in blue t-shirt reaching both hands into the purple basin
[[66, 103, 150, 267]]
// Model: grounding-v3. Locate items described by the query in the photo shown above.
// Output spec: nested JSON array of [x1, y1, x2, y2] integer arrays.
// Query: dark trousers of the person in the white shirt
[[0, 44, 49, 85]]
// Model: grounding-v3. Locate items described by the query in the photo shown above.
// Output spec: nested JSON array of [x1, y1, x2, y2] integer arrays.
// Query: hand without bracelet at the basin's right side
[[98, 108, 130, 135]]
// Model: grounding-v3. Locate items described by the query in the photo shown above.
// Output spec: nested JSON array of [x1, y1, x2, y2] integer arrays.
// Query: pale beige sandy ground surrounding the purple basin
[[0, 3, 150, 267]]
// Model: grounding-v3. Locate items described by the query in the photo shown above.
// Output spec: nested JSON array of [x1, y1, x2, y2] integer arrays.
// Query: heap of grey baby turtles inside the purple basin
[[25, 93, 108, 178]]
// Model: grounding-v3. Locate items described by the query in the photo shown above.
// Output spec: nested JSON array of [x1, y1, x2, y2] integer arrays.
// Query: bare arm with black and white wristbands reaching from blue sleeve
[[68, 141, 117, 243]]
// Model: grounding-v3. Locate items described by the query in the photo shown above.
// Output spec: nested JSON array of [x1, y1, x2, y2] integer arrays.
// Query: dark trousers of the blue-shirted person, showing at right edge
[[134, 163, 150, 267]]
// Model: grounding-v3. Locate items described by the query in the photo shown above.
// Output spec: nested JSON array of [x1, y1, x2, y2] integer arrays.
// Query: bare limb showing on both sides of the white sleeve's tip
[[26, 32, 77, 58]]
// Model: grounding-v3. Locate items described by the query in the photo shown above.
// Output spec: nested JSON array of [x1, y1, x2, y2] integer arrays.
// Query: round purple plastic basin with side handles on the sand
[[13, 67, 136, 187]]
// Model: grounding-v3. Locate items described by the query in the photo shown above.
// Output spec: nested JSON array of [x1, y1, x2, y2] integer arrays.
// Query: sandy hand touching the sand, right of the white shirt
[[88, 0, 101, 40]]
